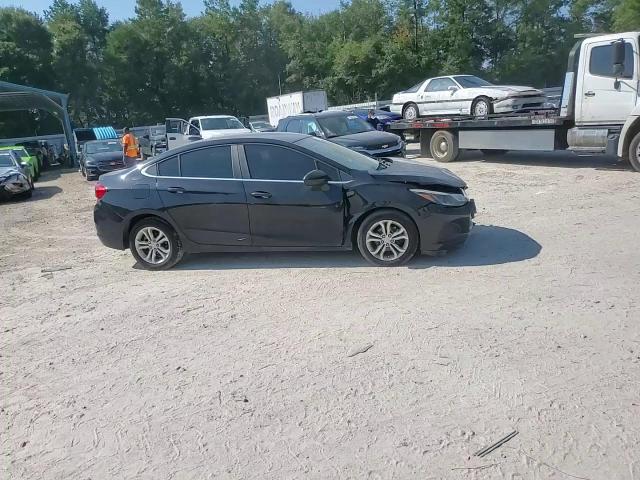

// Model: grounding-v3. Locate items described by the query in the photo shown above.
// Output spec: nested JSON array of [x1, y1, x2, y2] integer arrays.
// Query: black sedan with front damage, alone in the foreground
[[94, 132, 476, 270]]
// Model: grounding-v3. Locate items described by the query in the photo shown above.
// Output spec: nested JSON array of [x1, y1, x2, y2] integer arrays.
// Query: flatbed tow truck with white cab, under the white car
[[390, 32, 640, 171]]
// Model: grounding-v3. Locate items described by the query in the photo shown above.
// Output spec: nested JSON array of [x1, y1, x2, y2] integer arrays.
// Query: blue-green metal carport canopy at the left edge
[[0, 81, 76, 162]]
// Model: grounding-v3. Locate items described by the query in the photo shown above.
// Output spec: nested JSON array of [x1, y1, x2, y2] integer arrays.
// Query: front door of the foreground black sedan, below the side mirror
[[241, 143, 345, 247]]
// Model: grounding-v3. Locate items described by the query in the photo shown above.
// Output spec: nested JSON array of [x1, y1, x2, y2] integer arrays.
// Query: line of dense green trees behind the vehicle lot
[[0, 0, 640, 137]]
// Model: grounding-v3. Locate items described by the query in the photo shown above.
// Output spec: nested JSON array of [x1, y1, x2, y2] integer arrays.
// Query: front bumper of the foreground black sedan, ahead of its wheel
[[418, 200, 477, 254]]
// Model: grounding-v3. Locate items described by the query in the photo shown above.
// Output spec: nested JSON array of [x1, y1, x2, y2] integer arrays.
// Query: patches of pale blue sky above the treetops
[[0, 0, 340, 21]]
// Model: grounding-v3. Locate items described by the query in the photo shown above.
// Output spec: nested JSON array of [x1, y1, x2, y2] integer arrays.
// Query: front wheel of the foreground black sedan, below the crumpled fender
[[357, 210, 420, 267]]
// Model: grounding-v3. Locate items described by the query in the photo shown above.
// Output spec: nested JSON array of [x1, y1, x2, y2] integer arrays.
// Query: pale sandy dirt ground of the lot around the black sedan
[[0, 148, 640, 480]]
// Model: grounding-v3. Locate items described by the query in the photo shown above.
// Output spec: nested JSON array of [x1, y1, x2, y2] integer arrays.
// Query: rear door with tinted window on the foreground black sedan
[[153, 145, 251, 246]]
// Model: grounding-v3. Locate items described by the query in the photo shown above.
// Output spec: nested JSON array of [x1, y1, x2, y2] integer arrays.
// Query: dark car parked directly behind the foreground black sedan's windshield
[[278, 111, 405, 157]]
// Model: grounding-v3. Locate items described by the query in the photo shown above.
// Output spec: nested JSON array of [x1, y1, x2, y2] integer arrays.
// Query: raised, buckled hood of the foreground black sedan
[[369, 158, 467, 188]]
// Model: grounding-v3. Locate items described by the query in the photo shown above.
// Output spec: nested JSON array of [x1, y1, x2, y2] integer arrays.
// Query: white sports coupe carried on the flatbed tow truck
[[390, 75, 547, 120]]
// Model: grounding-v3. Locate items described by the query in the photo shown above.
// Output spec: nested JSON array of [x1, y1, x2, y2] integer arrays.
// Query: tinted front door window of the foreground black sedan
[[244, 144, 316, 181]]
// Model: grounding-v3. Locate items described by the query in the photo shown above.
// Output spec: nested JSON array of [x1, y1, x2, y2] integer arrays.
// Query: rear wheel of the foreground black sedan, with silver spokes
[[129, 218, 184, 270]]
